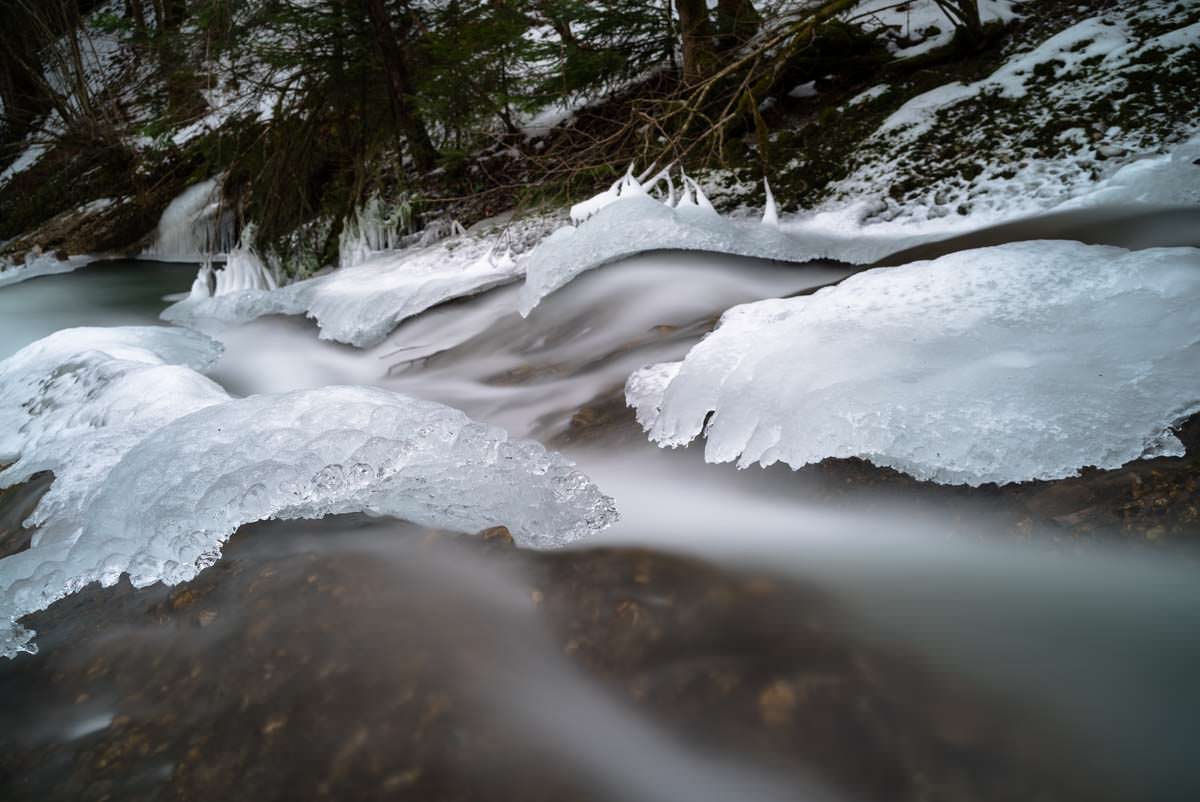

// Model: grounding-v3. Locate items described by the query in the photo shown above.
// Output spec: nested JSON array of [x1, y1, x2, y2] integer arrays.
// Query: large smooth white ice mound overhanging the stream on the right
[[626, 241, 1200, 485]]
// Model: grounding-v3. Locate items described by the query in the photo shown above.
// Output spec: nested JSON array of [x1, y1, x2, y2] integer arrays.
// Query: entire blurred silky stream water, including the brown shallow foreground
[[0, 208, 1200, 801]]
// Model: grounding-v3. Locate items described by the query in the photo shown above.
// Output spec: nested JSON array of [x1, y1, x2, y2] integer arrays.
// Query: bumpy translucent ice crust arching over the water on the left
[[0, 327, 617, 657]]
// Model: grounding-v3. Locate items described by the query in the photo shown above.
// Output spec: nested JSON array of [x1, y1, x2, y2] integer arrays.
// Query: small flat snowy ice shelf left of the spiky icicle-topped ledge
[[162, 231, 520, 347]]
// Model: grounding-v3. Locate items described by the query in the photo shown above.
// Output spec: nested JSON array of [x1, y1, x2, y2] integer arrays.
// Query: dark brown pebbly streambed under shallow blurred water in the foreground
[[0, 519, 1106, 802]]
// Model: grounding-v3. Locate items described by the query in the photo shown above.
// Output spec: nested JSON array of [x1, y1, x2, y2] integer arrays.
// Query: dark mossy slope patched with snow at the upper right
[[818, 0, 1200, 232]]
